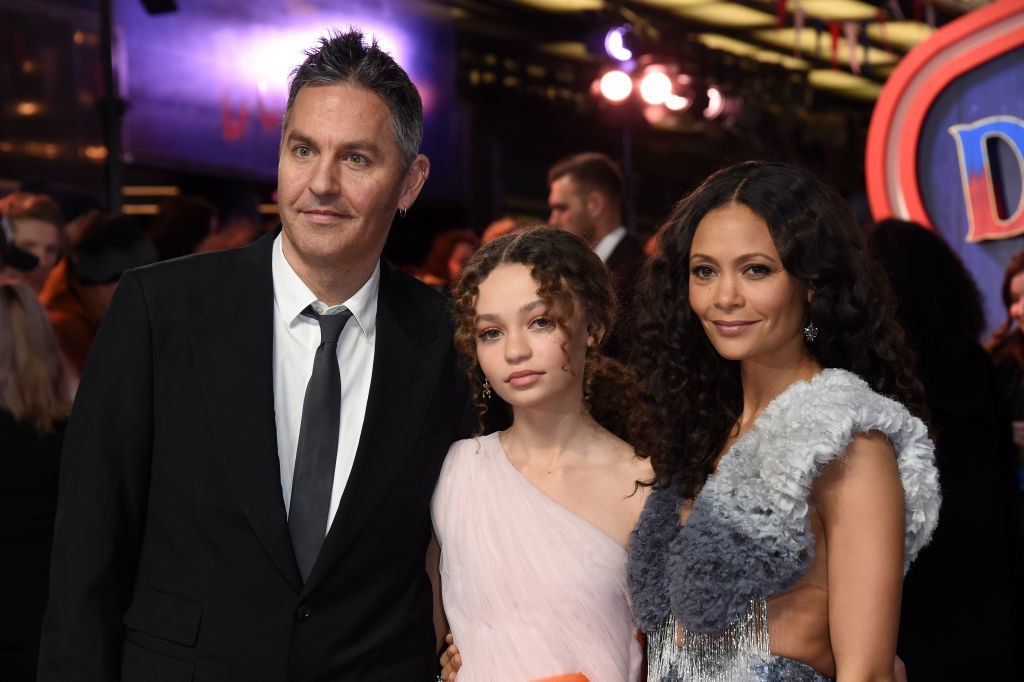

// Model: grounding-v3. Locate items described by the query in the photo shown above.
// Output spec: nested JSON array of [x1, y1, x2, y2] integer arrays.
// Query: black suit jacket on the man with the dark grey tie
[[39, 229, 466, 682]]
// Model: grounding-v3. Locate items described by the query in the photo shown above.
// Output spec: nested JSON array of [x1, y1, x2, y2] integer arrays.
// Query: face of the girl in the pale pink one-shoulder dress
[[474, 264, 589, 411]]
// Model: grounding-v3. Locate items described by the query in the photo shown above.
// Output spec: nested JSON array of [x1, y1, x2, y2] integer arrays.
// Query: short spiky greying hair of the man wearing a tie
[[282, 27, 423, 168]]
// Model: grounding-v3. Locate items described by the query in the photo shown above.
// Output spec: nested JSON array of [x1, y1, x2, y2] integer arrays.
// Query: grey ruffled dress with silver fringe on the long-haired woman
[[629, 369, 940, 682]]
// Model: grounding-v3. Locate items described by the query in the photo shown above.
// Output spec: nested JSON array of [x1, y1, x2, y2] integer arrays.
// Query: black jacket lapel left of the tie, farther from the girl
[[187, 229, 302, 590]]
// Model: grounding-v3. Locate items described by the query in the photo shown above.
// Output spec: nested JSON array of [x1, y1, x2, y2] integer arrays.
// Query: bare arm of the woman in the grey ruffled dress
[[812, 432, 903, 682]]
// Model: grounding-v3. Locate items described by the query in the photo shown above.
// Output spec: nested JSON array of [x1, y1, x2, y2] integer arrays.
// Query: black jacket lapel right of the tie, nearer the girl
[[304, 263, 451, 592]]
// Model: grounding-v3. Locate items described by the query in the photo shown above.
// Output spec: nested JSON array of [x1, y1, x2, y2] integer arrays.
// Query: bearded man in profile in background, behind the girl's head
[[548, 152, 646, 357]]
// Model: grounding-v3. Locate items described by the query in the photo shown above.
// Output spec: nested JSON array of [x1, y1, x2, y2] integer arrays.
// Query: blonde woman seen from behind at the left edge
[[0, 284, 71, 682]]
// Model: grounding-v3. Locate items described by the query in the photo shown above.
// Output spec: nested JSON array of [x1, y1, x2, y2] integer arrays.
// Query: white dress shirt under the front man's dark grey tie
[[270, 235, 381, 528]]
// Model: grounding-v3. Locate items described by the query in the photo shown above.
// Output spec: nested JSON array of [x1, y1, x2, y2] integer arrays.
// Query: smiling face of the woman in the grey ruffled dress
[[689, 204, 809, 367]]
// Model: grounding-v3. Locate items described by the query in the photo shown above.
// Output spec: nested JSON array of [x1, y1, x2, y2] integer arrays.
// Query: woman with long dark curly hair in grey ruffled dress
[[630, 162, 939, 682]]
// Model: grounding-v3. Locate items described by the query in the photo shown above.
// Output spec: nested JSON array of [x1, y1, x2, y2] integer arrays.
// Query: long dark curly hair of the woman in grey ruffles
[[632, 162, 924, 491]]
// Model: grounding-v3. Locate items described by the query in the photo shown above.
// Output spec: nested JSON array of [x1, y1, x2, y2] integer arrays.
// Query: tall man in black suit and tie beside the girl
[[39, 31, 466, 682]]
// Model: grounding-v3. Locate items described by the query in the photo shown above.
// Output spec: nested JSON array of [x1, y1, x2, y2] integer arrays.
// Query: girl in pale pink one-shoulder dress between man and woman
[[432, 228, 652, 682]]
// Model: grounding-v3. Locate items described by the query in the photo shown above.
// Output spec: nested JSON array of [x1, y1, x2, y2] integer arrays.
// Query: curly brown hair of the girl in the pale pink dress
[[454, 227, 638, 441]]
